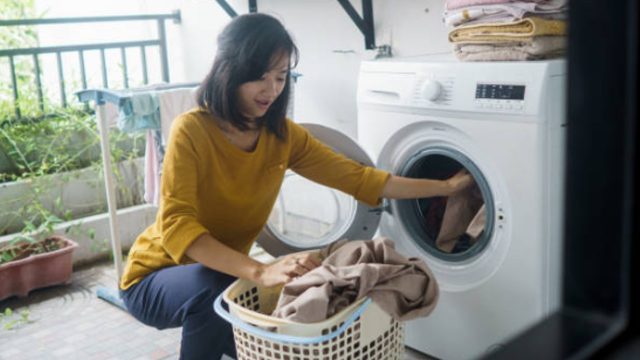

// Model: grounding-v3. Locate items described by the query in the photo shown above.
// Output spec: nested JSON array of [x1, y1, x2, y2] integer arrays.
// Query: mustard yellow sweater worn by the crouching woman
[[120, 109, 389, 289]]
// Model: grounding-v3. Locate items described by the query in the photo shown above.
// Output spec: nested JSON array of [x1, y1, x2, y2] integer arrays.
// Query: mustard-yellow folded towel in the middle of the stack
[[449, 17, 566, 43]]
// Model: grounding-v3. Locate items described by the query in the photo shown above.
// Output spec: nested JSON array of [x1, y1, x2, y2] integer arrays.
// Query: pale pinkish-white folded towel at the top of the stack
[[443, 0, 568, 26]]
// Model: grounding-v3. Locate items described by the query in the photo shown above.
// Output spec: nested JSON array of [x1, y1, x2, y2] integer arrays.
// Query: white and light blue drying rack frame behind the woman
[[76, 83, 198, 309]]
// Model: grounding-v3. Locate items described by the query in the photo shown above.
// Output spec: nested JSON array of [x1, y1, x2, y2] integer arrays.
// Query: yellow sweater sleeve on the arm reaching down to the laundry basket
[[160, 115, 208, 264]]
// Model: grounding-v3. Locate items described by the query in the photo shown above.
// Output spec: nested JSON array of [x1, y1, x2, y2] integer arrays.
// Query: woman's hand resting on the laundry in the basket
[[257, 252, 321, 287]]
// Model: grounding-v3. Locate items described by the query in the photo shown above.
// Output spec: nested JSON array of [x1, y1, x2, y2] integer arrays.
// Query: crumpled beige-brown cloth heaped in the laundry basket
[[272, 238, 439, 323]]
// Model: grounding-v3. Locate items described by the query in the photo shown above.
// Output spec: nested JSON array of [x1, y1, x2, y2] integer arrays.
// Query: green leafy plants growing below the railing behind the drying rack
[[0, 108, 144, 239]]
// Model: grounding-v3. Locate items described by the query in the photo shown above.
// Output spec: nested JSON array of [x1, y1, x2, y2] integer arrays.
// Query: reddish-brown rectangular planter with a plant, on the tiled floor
[[0, 221, 78, 300]]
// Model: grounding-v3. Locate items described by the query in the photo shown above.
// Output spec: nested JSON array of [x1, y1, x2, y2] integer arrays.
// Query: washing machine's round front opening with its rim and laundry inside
[[378, 120, 511, 291]]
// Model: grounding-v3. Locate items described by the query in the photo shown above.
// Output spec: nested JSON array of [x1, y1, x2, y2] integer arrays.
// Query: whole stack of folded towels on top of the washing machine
[[443, 0, 568, 61]]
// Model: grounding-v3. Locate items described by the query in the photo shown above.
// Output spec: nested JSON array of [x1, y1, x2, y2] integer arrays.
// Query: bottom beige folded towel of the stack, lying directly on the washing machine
[[454, 36, 567, 61]]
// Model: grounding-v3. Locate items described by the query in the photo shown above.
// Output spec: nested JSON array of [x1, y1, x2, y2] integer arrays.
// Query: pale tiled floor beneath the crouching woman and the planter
[[0, 262, 429, 360]]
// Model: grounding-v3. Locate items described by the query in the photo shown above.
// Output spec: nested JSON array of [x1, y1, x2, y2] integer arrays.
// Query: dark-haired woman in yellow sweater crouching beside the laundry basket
[[120, 14, 472, 359]]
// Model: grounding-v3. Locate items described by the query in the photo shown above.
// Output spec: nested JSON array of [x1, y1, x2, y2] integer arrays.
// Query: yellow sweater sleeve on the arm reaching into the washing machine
[[288, 121, 390, 206]]
